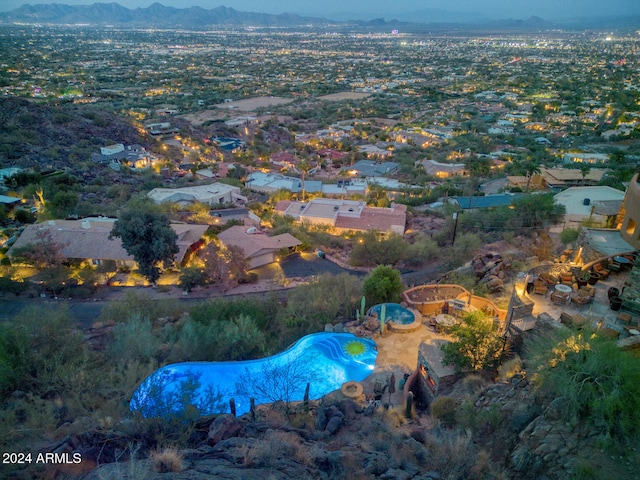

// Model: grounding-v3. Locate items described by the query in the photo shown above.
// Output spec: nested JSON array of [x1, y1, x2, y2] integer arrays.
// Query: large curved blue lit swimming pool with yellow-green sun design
[[129, 333, 378, 417]]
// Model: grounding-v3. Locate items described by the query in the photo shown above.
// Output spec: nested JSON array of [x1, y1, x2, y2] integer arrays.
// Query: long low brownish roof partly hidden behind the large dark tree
[[8, 217, 209, 266]]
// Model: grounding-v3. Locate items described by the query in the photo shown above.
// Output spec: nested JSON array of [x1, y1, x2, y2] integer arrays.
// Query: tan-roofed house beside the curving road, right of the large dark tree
[[218, 225, 302, 268]]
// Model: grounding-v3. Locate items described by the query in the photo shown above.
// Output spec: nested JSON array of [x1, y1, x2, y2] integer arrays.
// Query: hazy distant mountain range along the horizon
[[0, 3, 640, 31]]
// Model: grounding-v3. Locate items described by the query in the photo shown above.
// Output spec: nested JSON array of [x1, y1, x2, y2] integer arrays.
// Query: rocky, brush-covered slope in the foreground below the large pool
[[33, 361, 639, 480]]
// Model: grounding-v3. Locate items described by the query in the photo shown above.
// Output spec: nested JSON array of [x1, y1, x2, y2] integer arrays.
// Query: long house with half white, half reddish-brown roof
[[275, 198, 407, 235]]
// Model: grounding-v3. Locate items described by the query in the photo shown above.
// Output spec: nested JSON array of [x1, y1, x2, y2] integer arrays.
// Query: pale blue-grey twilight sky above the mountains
[[0, 0, 640, 20]]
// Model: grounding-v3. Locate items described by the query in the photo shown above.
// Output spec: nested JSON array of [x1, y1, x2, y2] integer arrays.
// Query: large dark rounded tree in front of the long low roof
[[109, 210, 178, 283]]
